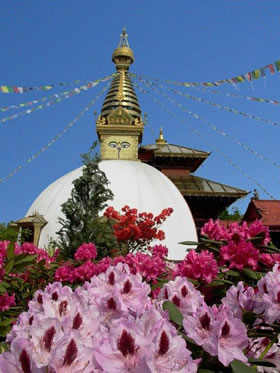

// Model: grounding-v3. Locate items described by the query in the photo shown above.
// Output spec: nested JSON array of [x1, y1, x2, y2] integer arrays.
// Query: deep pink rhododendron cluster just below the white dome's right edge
[[173, 250, 218, 284]]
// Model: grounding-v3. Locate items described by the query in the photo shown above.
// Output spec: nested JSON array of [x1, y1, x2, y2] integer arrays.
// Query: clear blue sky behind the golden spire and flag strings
[[0, 0, 280, 222]]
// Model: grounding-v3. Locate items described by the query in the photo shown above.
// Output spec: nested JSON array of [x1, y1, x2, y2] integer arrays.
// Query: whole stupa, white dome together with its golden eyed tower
[[22, 29, 197, 260]]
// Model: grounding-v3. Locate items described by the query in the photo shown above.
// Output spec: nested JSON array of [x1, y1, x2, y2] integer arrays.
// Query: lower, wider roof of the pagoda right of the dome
[[168, 175, 248, 198]]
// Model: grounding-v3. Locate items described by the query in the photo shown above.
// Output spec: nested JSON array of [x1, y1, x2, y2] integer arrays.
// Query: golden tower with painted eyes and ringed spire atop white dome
[[96, 28, 144, 160]]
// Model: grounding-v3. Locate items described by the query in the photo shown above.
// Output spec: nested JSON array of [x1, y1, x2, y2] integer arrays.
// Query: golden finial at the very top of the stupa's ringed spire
[[112, 27, 134, 71]]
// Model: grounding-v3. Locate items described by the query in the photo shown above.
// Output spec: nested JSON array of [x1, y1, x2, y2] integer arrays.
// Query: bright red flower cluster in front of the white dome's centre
[[104, 205, 173, 243]]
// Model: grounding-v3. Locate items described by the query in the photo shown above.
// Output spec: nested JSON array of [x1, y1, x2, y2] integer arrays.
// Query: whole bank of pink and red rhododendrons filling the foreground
[[0, 217, 280, 373]]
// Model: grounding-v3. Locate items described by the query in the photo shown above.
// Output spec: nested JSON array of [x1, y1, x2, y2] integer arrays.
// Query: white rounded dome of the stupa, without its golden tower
[[26, 160, 197, 260]]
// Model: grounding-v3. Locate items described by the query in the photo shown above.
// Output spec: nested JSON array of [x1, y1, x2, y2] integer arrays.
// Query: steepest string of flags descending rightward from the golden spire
[[134, 81, 275, 199]]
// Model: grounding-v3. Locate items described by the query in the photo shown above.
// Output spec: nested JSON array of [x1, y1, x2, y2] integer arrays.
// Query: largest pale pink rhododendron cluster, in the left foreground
[[0, 263, 199, 373]]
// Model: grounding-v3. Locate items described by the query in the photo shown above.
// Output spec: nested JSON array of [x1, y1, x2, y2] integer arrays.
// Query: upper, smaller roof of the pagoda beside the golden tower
[[140, 143, 210, 159]]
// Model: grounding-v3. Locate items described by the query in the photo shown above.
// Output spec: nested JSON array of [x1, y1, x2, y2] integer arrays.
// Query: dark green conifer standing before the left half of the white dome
[[56, 143, 116, 259]]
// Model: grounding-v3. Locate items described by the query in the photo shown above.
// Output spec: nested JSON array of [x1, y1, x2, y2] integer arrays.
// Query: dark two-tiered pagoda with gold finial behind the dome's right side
[[139, 129, 248, 230]]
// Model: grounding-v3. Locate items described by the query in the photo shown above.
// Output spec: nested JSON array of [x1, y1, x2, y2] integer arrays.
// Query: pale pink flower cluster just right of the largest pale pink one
[[158, 277, 248, 366]]
